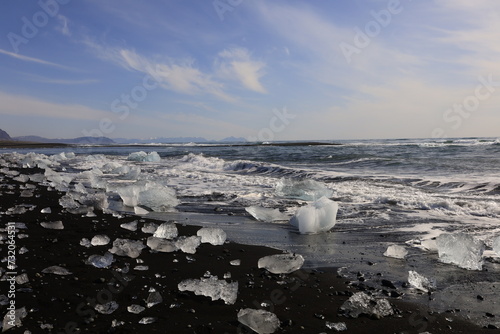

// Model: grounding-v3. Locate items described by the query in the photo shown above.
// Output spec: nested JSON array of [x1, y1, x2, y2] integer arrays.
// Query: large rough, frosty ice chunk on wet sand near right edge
[[436, 232, 485, 270]]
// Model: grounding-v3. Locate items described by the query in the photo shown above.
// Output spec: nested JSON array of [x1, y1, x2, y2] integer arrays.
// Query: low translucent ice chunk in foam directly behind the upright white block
[[275, 178, 333, 201]]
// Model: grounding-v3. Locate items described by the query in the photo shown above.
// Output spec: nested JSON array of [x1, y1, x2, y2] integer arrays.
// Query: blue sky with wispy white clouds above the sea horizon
[[0, 0, 500, 141]]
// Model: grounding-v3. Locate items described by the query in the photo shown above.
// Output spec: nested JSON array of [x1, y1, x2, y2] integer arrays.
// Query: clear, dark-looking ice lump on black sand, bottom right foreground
[[340, 292, 394, 319]]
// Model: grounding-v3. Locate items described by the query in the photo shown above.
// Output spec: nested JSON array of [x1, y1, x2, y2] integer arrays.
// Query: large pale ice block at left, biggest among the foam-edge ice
[[116, 181, 179, 212]]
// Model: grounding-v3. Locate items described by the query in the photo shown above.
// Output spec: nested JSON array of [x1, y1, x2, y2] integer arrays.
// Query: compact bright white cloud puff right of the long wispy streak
[[216, 47, 267, 93]]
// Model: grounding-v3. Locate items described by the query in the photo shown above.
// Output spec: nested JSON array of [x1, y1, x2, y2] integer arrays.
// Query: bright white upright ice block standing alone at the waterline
[[290, 197, 339, 234]]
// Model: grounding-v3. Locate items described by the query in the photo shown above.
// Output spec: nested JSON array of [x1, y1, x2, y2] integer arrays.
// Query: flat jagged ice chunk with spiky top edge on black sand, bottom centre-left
[[177, 276, 238, 305]]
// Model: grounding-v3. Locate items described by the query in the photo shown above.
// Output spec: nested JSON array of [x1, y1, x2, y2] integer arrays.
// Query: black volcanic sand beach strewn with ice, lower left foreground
[[0, 169, 492, 334]]
